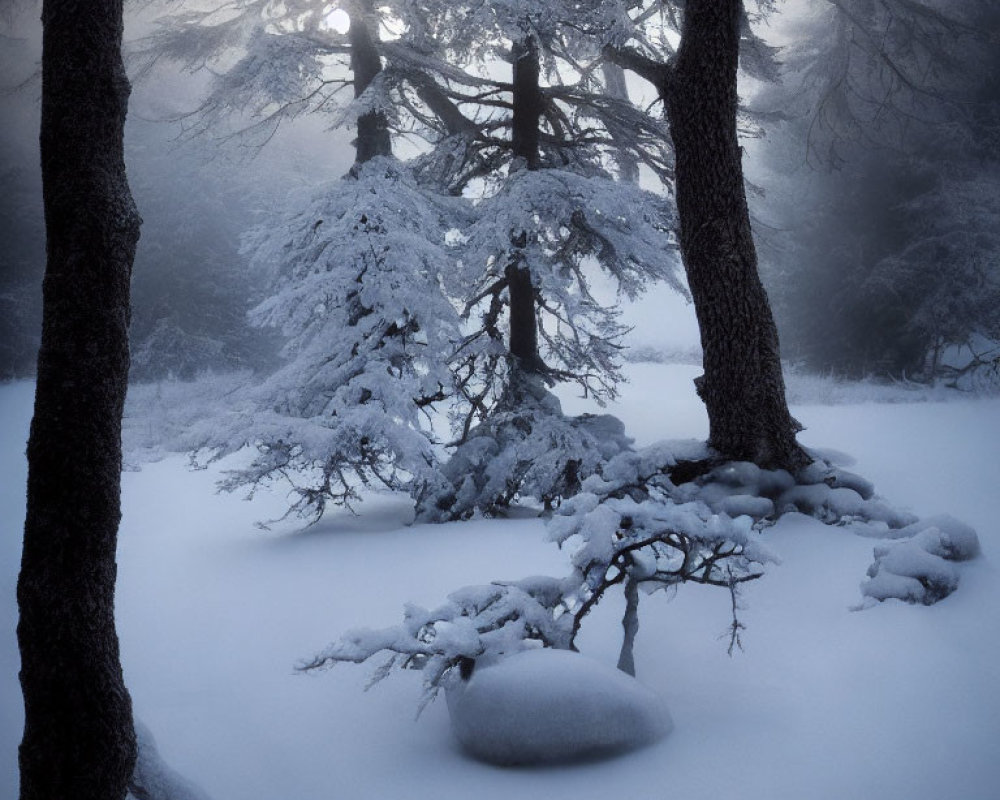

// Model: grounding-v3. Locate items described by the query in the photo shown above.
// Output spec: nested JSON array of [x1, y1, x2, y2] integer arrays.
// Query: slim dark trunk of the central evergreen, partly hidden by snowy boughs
[[506, 36, 543, 372]]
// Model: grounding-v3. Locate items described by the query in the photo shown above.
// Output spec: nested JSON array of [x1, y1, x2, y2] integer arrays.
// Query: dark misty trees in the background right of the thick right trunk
[[758, 0, 1000, 380]]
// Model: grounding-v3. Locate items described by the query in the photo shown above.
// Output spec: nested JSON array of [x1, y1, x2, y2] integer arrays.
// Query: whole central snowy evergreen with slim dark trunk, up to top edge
[[390, 3, 679, 519]]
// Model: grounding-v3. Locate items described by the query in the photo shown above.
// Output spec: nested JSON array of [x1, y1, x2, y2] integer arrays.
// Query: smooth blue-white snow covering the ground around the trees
[[0, 364, 1000, 800]]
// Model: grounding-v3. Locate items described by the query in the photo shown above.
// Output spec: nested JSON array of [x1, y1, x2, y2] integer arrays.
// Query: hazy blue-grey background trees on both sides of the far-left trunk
[[0, 117, 277, 381]]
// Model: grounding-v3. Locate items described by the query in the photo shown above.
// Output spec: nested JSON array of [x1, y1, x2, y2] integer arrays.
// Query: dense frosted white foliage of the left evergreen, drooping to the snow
[[198, 157, 469, 519]]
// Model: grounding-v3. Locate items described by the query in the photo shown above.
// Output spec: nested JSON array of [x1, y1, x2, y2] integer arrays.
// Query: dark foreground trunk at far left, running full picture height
[[17, 0, 140, 800]]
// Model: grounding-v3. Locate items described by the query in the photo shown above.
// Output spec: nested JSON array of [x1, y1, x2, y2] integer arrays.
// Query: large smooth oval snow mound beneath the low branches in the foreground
[[447, 648, 673, 765]]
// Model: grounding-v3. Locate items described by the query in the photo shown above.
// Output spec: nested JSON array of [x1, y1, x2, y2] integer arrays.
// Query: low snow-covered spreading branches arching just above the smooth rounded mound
[[301, 438, 777, 703]]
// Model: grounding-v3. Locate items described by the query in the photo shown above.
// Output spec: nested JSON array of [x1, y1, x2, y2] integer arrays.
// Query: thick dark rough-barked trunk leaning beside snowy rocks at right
[[665, 0, 806, 471]]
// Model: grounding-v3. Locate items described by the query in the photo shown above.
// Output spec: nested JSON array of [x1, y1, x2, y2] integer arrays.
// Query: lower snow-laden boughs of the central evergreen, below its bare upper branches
[[418, 168, 683, 519]]
